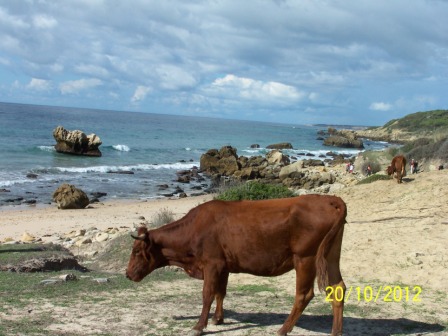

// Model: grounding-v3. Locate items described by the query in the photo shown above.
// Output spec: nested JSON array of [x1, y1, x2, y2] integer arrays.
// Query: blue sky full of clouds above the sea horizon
[[0, 0, 448, 126]]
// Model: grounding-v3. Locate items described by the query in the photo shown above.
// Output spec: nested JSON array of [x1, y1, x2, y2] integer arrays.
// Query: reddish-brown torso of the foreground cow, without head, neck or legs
[[192, 195, 346, 275]]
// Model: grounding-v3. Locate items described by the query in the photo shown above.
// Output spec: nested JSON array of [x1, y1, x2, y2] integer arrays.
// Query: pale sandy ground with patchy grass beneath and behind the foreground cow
[[0, 170, 448, 336]]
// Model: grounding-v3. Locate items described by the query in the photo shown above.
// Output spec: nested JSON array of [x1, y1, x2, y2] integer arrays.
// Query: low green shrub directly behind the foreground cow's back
[[215, 181, 293, 201]]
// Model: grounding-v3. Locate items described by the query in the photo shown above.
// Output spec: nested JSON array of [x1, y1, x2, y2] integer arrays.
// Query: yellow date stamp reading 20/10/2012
[[325, 285, 422, 302]]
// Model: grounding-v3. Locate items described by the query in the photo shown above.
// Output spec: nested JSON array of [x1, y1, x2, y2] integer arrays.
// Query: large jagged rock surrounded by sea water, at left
[[53, 126, 102, 156]]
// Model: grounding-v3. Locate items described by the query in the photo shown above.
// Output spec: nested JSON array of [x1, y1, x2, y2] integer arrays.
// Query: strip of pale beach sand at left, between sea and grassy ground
[[0, 194, 214, 242]]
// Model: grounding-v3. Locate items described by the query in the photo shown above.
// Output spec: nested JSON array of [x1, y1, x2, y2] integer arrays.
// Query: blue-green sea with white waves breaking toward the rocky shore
[[0, 103, 387, 208]]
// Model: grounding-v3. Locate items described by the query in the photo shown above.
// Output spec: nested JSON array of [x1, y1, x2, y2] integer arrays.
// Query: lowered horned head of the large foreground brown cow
[[126, 227, 157, 282]]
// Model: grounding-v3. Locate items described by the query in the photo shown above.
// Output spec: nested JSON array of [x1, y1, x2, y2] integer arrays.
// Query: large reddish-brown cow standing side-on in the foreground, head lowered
[[126, 195, 347, 336]]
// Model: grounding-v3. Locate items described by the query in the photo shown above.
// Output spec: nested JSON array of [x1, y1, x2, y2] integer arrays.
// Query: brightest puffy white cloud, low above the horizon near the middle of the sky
[[211, 74, 304, 101]]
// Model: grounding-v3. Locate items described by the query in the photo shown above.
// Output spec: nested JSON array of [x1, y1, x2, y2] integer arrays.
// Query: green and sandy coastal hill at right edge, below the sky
[[356, 110, 448, 143]]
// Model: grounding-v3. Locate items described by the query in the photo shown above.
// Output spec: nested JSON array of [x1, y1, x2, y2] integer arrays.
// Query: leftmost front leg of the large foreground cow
[[189, 269, 219, 336]]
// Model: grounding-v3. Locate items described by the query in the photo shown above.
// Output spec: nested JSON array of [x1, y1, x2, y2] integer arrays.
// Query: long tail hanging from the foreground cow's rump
[[316, 198, 347, 291]]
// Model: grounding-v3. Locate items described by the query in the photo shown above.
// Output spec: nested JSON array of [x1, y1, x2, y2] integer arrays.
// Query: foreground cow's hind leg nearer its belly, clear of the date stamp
[[277, 256, 316, 336]]
